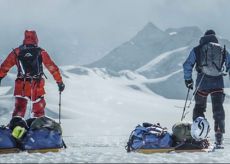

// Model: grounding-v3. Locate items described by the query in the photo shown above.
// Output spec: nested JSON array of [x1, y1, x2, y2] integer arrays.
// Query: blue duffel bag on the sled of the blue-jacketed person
[[126, 123, 173, 152]]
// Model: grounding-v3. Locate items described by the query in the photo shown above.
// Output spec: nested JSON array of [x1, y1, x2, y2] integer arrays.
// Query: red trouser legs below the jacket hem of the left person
[[12, 97, 46, 117]]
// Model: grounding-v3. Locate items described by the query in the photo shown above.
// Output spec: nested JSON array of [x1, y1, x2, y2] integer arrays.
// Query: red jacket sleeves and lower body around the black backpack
[[0, 48, 62, 100]]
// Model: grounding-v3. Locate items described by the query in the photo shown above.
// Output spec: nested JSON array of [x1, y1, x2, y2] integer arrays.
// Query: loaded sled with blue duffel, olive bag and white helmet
[[125, 119, 215, 154]]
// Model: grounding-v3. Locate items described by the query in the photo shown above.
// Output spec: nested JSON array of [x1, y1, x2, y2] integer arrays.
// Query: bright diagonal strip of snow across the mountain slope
[[136, 46, 188, 72]]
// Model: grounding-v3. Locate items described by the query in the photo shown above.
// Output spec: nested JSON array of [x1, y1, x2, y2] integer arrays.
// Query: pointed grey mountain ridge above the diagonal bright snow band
[[86, 23, 202, 71]]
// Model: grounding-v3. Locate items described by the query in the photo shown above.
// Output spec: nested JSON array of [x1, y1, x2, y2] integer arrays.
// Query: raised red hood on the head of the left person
[[23, 30, 38, 46]]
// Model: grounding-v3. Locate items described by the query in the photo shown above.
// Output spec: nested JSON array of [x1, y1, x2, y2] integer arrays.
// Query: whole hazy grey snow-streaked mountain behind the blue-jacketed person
[[87, 23, 230, 99]]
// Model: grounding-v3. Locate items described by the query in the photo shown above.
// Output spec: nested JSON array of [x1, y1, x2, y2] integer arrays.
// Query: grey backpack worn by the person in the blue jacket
[[195, 42, 226, 76]]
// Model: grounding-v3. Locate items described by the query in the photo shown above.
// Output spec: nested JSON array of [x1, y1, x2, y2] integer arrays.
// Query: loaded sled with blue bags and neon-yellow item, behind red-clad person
[[0, 116, 66, 154]]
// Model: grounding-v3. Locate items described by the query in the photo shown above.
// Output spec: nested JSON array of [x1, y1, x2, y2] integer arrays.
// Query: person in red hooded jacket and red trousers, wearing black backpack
[[0, 30, 65, 117]]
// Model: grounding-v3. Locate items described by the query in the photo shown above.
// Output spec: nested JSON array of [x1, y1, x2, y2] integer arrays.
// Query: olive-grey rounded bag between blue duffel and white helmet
[[172, 122, 193, 142]]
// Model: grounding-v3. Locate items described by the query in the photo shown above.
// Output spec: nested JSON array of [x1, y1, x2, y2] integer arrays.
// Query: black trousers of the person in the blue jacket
[[193, 89, 225, 133]]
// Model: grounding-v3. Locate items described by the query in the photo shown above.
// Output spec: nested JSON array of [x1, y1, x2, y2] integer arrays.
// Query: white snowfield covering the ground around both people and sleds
[[0, 66, 230, 163]]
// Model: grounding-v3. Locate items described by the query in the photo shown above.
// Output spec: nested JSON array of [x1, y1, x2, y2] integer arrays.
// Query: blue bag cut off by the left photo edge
[[0, 126, 17, 149]]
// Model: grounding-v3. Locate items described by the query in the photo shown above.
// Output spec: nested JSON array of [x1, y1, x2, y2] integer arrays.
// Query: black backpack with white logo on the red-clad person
[[17, 47, 44, 79]]
